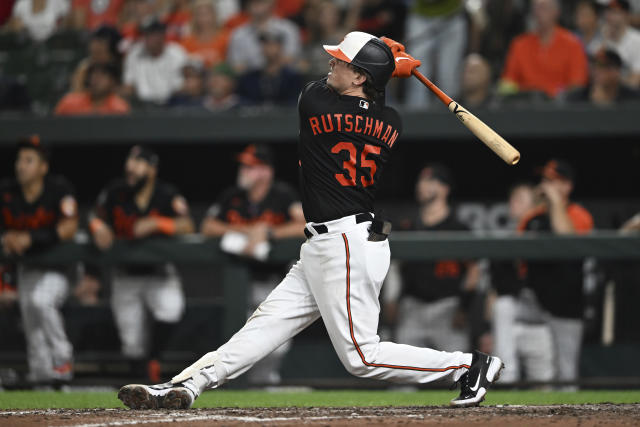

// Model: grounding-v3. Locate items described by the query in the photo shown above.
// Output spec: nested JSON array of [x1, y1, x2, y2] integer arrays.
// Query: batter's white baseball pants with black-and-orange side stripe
[[172, 216, 472, 389]]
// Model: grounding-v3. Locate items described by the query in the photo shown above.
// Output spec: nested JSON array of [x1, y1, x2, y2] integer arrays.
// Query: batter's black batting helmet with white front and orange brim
[[323, 31, 396, 91]]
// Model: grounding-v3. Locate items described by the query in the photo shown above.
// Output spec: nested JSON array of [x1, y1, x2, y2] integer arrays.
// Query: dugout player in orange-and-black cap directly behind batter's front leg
[[200, 145, 305, 385]]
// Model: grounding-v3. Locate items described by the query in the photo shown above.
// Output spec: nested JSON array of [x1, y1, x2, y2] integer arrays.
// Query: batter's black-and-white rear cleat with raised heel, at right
[[451, 350, 504, 407]]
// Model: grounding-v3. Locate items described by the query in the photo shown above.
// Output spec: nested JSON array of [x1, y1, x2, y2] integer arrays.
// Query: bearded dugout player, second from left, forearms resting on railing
[[90, 145, 194, 381]]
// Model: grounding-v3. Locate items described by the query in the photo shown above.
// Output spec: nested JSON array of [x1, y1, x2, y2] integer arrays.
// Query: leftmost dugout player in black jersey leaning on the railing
[[0, 135, 78, 384]]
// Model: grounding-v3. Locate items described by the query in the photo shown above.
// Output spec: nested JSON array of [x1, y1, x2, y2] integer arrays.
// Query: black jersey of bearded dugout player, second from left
[[95, 179, 189, 239]]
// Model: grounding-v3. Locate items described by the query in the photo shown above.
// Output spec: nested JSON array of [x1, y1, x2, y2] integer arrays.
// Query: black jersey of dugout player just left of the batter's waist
[[207, 182, 299, 226]]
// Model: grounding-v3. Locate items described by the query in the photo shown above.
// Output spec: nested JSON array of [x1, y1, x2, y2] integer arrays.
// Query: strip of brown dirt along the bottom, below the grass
[[0, 404, 640, 427]]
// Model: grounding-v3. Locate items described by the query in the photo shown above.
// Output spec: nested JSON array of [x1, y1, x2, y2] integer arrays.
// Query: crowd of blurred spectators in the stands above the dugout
[[0, 0, 640, 114]]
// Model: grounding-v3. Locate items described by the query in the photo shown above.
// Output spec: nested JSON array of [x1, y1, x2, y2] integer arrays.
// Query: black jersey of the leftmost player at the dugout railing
[[0, 176, 78, 249]]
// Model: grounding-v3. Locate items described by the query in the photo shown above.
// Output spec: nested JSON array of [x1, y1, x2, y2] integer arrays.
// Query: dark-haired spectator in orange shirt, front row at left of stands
[[55, 64, 130, 115]]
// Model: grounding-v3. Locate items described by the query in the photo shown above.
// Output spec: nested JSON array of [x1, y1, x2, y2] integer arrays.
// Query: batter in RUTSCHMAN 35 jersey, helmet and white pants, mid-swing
[[118, 32, 503, 409]]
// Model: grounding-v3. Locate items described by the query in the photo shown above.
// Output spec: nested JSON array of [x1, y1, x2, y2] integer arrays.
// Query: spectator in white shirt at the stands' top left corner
[[9, 0, 70, 42]]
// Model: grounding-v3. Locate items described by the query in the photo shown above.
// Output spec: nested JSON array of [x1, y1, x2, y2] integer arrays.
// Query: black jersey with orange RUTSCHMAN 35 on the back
[[298, 79, 402, 222]]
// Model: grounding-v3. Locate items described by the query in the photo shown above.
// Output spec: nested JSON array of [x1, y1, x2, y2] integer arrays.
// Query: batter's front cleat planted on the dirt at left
[[118, 383, 195, 409]]
